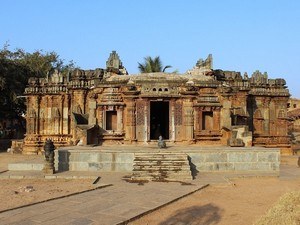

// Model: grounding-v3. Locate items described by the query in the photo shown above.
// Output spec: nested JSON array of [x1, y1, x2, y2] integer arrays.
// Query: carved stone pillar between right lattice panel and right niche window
[[183, 99, 194, 142]]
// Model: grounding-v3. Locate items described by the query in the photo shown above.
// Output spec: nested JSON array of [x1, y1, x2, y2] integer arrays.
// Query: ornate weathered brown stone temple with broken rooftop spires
[[23, 51, 290, 154]]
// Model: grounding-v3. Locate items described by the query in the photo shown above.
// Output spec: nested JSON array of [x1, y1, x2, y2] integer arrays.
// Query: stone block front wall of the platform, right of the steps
[[188, 148, 280, 172]]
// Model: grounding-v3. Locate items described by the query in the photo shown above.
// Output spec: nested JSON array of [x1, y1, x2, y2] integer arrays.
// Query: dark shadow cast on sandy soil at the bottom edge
[[159, 204, 222, 225]]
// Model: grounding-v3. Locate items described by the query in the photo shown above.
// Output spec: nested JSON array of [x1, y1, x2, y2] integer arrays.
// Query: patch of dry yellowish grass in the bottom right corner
[[255, 191, 300, 225]]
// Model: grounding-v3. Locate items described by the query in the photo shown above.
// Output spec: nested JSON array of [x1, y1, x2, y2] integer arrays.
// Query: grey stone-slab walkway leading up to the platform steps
[[0, 154, 300, 225]]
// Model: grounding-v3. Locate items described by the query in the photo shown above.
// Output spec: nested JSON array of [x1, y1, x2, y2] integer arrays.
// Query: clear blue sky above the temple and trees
[[0, 0, 300, 98]]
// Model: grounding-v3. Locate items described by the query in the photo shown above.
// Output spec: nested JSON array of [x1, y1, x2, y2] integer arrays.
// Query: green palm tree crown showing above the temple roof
[[138, 56, 172, 73]]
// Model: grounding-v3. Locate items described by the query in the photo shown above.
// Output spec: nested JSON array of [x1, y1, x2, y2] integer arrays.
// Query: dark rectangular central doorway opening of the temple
[[150, 101, 169, 140]]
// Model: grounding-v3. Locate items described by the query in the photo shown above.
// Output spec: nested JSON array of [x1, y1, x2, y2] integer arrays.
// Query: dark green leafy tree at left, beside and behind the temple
[[0, 44, 74, 119]]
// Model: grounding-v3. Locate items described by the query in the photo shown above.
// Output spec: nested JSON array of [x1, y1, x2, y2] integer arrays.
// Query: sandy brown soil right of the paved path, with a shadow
[[130, 178, 300, 225]]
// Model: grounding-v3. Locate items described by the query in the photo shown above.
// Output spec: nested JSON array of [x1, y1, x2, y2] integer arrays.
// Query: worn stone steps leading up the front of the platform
[[131, 151, 193, 181]]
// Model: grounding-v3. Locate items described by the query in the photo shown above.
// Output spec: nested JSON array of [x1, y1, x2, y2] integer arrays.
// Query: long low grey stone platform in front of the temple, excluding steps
[[55, 145, 280, 174]]
